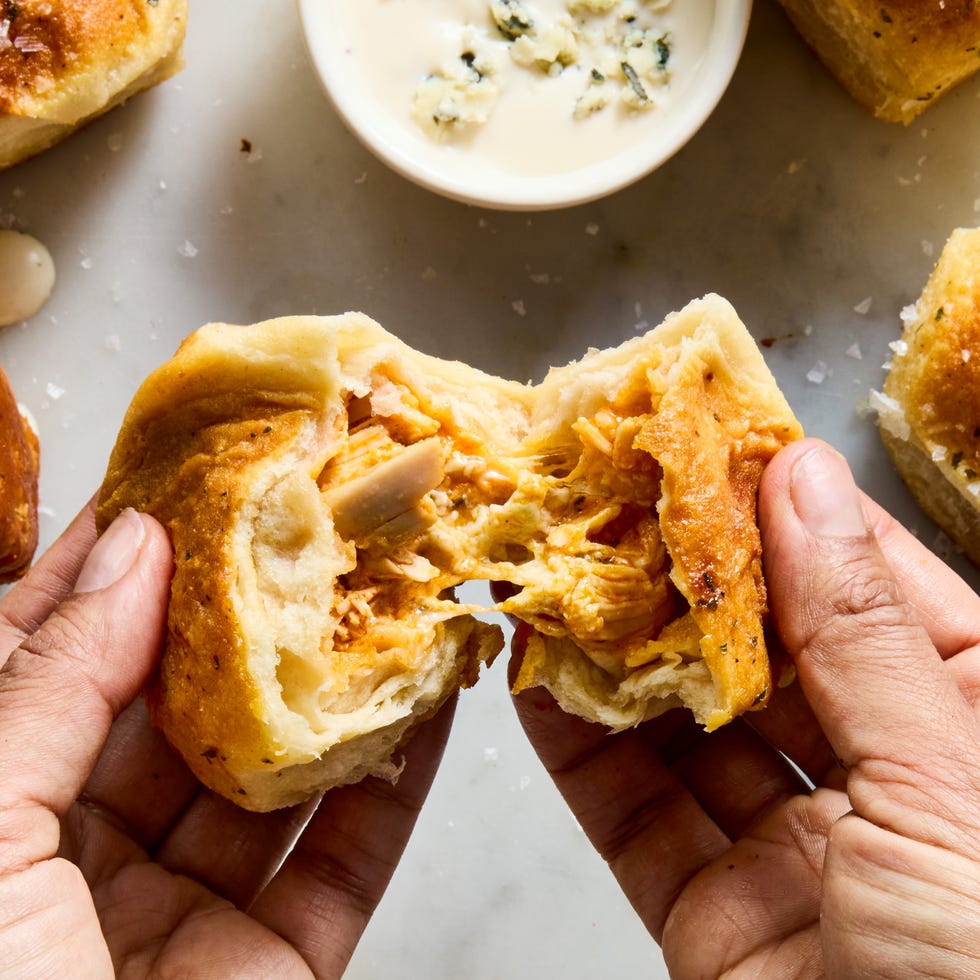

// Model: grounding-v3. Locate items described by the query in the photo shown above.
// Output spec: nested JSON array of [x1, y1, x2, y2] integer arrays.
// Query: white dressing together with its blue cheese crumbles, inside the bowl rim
[[332, 0, 713, 177]]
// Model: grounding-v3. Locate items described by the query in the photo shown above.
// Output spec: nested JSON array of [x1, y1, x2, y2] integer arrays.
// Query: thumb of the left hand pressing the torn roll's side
[[0, 511, 171, 871]]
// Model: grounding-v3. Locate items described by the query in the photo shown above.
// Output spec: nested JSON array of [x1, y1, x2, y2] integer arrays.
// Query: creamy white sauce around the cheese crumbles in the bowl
[[326, 0, 714, 177]]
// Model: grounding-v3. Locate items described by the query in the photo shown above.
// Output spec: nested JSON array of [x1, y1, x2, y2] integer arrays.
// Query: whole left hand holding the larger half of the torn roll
[[0, 509, 453, 980]]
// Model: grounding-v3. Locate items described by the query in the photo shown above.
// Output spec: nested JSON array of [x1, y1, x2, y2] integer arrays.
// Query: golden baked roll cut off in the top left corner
[[0, 0, 187, 169]]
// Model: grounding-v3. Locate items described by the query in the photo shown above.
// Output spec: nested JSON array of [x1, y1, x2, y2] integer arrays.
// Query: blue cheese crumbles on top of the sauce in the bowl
[[413, 0, 673, 141]]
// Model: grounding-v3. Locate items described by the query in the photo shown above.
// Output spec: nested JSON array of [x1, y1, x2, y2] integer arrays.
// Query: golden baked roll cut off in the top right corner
[[780, 0, 980, 124]]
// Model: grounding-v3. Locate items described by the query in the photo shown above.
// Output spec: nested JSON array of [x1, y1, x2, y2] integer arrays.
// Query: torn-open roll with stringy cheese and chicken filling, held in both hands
[[98, 296, 801, 810]]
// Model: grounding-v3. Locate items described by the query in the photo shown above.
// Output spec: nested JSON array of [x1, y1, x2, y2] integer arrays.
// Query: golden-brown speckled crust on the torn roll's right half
[[637, 349, 800, 727]]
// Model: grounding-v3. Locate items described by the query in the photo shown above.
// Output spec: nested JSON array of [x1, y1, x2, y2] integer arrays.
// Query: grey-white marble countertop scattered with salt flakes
[[0, 0, 980, 980]]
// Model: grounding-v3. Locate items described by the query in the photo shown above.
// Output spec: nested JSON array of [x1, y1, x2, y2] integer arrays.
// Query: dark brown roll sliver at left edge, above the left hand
[[0, 369, 40, 584]]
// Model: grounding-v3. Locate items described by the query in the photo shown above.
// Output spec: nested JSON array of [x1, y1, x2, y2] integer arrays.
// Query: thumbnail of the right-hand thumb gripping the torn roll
[[790, 449, 867, 538]]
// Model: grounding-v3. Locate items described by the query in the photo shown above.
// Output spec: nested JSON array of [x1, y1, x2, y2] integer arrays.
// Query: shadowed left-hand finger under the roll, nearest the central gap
[[252, 699, 455, 976]]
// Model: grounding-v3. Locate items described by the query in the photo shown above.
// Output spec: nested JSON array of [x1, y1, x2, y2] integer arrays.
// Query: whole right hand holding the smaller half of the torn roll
[[516, 440, 980, 980]]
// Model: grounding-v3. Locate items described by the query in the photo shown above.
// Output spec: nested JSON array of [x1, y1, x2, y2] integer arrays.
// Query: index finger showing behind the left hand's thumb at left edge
[[0, 501, 96, 667]]
